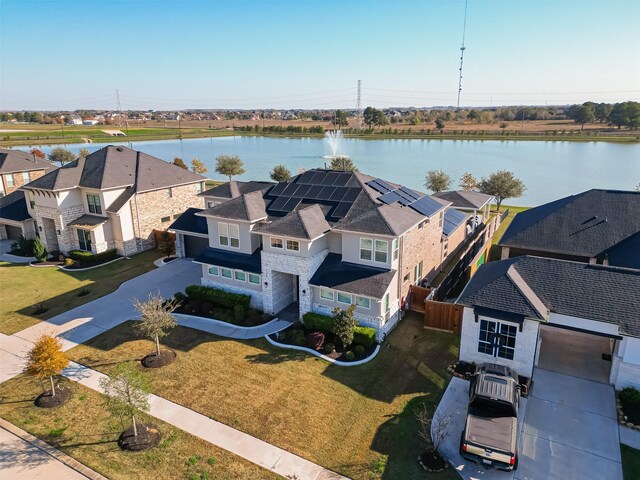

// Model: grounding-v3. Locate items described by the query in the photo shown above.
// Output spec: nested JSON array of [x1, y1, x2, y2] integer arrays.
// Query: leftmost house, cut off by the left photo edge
[[0, 148, 56, 240]]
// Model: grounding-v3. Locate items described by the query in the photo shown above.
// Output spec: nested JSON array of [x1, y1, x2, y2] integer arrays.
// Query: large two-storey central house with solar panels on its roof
[[169, 169, 469, 335]]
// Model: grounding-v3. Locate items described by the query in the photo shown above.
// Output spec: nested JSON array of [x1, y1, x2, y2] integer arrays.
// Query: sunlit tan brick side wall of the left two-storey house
[[130, 183, 202, 249]]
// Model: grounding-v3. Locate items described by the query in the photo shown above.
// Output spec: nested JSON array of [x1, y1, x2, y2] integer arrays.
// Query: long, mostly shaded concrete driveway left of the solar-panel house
[[0, 259, 202, 383]]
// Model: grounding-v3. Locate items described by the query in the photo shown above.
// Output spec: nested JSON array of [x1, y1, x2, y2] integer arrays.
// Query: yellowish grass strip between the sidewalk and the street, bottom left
[[0, 376, 280, 480]]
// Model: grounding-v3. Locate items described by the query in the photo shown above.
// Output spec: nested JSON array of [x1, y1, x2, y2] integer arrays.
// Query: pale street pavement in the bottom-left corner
[[0, 419, 107, 480]]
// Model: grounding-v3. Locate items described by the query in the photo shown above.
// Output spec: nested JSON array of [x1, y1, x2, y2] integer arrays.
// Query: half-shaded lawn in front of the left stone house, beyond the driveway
[[0, 250, 162, 335]]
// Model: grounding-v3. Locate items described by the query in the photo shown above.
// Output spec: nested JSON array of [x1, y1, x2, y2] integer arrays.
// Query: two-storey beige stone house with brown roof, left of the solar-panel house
[[22, 145, 205, 255]]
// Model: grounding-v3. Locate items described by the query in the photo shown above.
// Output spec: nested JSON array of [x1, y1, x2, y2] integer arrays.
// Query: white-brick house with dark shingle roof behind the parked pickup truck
[[457, 256, 640, 388]]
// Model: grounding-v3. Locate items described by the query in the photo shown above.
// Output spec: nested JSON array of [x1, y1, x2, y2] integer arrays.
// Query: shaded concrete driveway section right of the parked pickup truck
[[514, 368, 622, 480]]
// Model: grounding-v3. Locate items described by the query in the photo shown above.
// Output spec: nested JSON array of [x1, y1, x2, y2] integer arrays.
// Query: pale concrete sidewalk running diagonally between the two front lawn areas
[[62, 362, 346, 480]]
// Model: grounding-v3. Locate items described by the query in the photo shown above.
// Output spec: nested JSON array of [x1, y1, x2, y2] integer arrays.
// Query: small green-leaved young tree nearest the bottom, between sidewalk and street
[[100, 362, 151, 437]]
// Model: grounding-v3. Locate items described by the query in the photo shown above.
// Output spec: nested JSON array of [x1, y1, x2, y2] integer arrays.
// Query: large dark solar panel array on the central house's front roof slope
[[266, 170, 361, 220]]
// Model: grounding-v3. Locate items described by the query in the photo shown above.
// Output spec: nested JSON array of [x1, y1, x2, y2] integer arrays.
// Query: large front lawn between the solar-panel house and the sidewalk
[[69, 316, 459, 480]]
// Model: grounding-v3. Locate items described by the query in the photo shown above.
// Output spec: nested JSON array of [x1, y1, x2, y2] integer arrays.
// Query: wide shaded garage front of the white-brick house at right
[[536, 325, 616, 383]]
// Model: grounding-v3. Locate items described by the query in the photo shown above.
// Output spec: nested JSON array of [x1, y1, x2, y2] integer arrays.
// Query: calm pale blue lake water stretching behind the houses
[[36, 137, 640, 205]]
